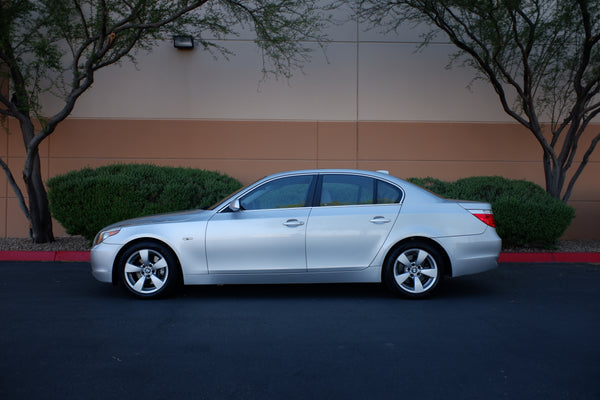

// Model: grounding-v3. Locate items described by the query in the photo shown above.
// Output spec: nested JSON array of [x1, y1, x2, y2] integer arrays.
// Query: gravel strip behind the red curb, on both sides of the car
[[0, 236, 600, 253]]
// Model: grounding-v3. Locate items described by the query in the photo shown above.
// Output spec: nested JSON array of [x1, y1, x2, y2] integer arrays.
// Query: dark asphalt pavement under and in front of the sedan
[[0, 261, 600, 400]]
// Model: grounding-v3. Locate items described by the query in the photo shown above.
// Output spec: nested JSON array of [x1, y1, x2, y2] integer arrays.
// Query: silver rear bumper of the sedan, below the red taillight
[[438, 229, 502, 277]]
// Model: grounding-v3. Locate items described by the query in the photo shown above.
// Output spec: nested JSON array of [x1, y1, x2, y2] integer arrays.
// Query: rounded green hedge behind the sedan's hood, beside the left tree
[[47, 164, 242, 241]]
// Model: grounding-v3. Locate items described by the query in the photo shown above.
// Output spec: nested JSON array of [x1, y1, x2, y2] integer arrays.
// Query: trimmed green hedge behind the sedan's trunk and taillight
[[408, 176, 575, 248]]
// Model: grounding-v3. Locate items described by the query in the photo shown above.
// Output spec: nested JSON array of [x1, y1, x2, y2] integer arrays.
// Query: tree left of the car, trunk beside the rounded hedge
[[0, 0, 326, 243]]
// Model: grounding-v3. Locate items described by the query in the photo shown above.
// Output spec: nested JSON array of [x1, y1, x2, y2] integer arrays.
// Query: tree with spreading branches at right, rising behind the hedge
[[357, 0, 600, 202]]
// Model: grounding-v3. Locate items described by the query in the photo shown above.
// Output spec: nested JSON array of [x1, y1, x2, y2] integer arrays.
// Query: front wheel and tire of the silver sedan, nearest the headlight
[[118, 242, 181, 299]]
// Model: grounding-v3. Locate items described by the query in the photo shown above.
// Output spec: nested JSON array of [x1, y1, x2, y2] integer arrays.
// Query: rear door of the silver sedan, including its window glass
[[306, 174, 402, 271]]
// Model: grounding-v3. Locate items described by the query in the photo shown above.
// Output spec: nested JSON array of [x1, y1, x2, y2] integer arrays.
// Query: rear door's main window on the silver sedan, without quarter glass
[[319, 175, 375, 206]]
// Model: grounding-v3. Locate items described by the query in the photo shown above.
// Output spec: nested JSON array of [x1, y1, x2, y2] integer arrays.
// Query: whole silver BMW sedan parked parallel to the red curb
[[91, 170, 501, 298]]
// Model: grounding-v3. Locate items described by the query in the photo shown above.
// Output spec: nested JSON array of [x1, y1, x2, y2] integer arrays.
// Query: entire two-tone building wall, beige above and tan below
[[0, 12, 600, 238]]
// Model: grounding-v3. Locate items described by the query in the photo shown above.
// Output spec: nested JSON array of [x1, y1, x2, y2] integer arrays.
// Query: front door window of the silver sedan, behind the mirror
[[240, 175, 313, 210]]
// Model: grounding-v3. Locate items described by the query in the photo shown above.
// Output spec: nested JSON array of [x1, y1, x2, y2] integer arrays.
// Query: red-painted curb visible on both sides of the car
[[0, 251, 600, 263]]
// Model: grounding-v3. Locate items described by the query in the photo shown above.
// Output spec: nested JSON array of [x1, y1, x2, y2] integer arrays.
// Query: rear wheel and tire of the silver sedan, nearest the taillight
[[383, 241, 446, 299]]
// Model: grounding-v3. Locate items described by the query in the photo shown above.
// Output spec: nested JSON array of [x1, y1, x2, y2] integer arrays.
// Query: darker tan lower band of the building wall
[[0, 119, 600, 238]]
